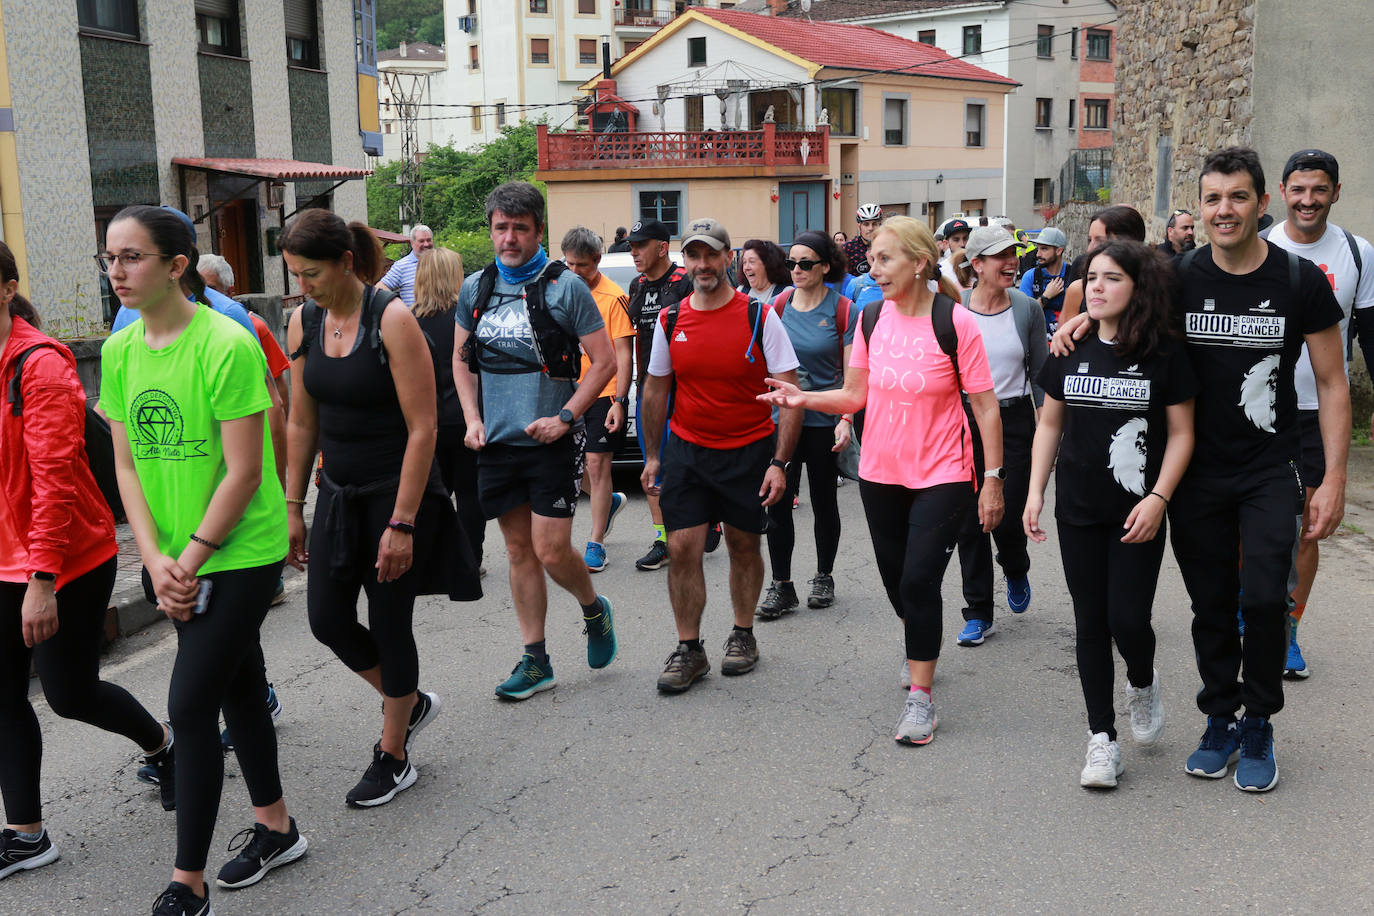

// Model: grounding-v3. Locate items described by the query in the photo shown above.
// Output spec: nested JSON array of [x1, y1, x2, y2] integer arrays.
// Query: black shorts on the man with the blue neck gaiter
[[477, 428, 587, 519]]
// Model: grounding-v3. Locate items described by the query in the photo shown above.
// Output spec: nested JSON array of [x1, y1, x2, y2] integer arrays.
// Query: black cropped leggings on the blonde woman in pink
[[859, 481, 973, 662]]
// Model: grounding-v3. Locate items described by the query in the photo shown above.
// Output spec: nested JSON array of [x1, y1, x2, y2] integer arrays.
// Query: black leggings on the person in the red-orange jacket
[[0, 558, 162, 824]]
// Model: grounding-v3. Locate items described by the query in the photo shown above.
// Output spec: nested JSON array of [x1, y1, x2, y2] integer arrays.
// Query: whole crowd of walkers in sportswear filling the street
[[0, 141, 1374, 916]]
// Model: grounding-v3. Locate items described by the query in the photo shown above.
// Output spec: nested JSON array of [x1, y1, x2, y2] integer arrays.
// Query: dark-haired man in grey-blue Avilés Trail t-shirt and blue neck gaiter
[[453, 181, 618, 700]]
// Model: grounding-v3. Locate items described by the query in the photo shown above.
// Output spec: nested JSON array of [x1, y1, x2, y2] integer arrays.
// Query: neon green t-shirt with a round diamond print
[[100, 305, 287, 574]]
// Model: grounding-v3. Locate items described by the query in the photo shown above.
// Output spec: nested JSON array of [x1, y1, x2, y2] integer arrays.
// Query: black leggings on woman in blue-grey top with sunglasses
[[768, 426, 840, 582]]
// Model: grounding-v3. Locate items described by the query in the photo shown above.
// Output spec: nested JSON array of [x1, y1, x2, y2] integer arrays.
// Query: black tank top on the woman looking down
[[304, 315, 409, 486]]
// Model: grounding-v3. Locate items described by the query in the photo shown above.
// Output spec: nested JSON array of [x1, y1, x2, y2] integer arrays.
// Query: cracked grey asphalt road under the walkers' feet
[[8, 448, 1374, 916]]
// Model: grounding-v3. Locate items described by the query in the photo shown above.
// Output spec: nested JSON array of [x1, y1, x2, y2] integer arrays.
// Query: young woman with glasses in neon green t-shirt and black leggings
[[100, 206, 306, 915]]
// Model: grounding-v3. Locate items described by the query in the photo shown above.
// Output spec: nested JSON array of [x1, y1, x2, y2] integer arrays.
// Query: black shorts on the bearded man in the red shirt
[[658, 435, 774, 534]]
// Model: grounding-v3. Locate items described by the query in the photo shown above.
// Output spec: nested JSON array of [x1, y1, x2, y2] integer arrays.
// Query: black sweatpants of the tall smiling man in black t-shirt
[[1169, 463, 1303, 715]]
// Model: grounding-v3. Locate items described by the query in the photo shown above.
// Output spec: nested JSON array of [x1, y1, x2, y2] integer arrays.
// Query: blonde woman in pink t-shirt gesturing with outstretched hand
[[760, 217, 1003, 744]]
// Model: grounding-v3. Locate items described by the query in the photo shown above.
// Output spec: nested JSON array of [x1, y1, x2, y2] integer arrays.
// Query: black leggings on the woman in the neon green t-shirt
[[168, 562, 282, 872]]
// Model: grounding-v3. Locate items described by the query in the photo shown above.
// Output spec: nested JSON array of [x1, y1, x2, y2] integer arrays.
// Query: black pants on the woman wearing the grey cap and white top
[[959, 397, 1035, 621]]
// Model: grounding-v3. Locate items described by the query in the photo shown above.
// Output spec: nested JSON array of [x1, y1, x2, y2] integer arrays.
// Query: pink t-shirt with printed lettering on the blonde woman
[[849, 299, 992, 490]]
